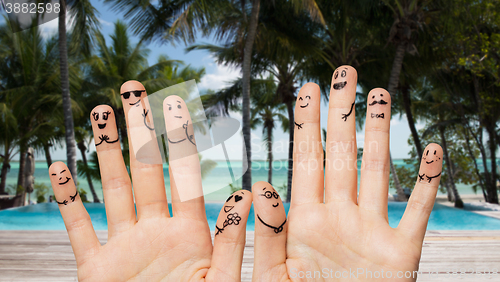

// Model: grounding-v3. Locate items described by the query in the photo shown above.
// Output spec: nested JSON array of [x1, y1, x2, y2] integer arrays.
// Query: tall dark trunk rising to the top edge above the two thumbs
[[242, 0, 260, 191]]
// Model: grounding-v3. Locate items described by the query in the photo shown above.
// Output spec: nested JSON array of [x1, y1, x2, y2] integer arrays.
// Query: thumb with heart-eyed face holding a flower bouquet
[[207, 190, 252, 281]]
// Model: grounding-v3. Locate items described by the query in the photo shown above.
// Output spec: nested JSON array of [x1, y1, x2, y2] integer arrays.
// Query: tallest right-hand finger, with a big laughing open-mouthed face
[[325, 66, 358, 203]]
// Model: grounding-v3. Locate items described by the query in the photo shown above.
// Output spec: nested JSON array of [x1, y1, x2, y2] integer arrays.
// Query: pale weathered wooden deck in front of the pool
[[0, 231, 500, 281]]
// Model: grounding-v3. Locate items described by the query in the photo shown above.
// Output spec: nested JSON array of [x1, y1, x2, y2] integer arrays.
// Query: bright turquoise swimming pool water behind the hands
[[0, 203, 500, 230]]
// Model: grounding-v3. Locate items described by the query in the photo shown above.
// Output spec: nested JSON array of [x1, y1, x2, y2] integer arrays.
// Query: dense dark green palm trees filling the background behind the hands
[[0, 0, 500, 207]]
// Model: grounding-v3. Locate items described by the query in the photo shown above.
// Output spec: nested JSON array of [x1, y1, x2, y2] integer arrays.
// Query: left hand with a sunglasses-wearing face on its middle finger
[[49, 81, 252, 282]]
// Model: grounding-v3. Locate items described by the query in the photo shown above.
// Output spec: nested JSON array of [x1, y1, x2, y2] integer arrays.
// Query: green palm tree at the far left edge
[[0, 21, 75, 205]]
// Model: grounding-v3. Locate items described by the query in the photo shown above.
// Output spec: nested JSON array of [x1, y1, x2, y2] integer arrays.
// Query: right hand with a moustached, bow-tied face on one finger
[[252, 66, 443, 281]]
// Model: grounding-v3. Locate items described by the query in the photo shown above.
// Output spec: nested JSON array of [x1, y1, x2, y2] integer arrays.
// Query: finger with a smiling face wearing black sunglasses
[[120, 80, 170, 220]]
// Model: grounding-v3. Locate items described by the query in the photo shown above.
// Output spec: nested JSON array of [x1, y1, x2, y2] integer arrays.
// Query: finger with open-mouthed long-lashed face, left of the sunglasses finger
[[90, 105, 135, 238]]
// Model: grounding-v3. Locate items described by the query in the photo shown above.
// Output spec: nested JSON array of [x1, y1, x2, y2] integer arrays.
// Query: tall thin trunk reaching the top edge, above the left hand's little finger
[[59, 0, 78, 185]]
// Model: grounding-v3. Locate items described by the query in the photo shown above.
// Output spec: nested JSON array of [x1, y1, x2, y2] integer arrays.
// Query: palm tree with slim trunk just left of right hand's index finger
[[187, 1, 326, 199]]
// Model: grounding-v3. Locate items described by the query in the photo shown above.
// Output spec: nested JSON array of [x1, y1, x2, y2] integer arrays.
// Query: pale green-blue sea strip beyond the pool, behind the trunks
[[0, 159, 480, 202]]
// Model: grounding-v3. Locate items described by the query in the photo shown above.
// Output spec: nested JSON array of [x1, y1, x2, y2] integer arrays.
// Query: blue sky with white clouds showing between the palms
[[2, 1, 425, 160]]
